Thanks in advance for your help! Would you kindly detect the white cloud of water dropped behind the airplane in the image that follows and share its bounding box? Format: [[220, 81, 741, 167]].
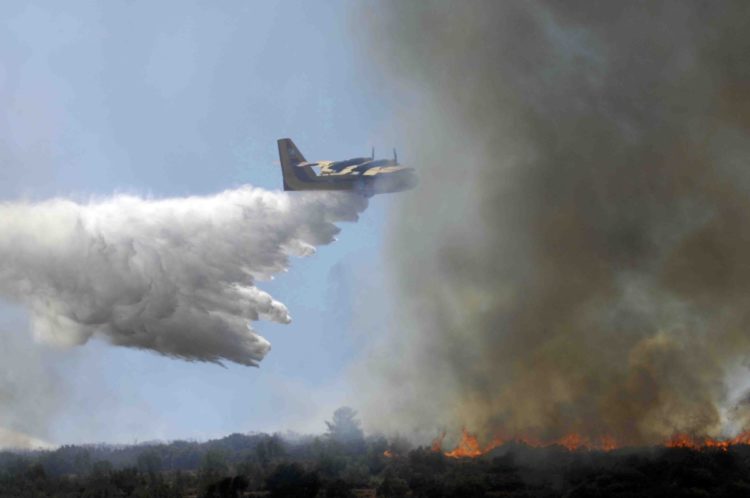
[[0, 187, 366, 365]]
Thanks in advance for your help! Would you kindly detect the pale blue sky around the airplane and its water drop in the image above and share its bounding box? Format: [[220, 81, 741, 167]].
[[0, 0, 400, 443]]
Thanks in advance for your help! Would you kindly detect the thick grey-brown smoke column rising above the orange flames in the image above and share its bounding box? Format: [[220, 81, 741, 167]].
[[362, 1, 750, 443]]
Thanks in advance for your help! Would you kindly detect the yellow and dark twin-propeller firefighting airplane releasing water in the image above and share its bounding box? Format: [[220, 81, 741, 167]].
[[278, 138, 417, 197]]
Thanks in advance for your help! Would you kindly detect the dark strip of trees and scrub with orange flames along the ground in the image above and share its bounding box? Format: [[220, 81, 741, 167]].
[[7, 431, 750, 498]]
